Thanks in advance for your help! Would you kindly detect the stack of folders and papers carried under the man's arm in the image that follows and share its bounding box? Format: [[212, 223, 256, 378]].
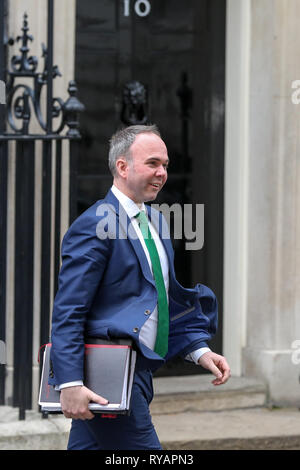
[[39, 338, 136, 414]]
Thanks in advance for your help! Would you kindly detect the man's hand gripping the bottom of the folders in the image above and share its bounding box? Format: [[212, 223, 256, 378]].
[[60, 385, 108, 419]]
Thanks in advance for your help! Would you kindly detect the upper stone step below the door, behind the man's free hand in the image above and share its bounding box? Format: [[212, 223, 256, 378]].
[[150, 375, 267, 415]]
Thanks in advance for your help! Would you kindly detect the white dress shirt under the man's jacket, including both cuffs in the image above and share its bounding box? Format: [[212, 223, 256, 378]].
[[58, 185, 210, 390]]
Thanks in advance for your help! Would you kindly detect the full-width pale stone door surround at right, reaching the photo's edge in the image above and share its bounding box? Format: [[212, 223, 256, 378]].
[[223, 0, 300, 406]]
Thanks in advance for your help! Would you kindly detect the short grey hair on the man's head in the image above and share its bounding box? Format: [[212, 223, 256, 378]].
[[108, 124, 161, 176]]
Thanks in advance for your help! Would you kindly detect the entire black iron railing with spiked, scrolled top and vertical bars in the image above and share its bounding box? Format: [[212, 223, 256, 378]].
[[0, 0, 84, 419]]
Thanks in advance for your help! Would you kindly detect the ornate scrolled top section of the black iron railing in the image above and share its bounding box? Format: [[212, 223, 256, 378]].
[[4, 11, 84, 138]]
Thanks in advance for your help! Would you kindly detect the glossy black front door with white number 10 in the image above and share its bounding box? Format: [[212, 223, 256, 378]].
[[75, 0, 226, 375]]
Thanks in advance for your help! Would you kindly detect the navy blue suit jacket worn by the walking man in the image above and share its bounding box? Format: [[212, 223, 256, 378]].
[[50, 191, 217, 384]]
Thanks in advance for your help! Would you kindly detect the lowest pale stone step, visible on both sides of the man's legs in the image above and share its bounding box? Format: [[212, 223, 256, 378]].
[[0, 407, 300, 450]]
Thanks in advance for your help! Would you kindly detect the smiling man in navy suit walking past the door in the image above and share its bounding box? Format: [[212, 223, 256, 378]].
[[50, 126, 230, 449]]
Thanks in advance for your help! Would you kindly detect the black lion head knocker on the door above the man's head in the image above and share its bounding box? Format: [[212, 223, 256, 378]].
[[121, 81, 148, 126]]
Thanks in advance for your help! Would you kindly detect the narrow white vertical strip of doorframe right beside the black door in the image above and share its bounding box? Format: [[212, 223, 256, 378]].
[[223, 0, 251, 376]]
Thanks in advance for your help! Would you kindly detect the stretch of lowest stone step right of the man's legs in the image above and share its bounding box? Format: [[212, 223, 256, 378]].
[[153, 408, 300, 450]]
